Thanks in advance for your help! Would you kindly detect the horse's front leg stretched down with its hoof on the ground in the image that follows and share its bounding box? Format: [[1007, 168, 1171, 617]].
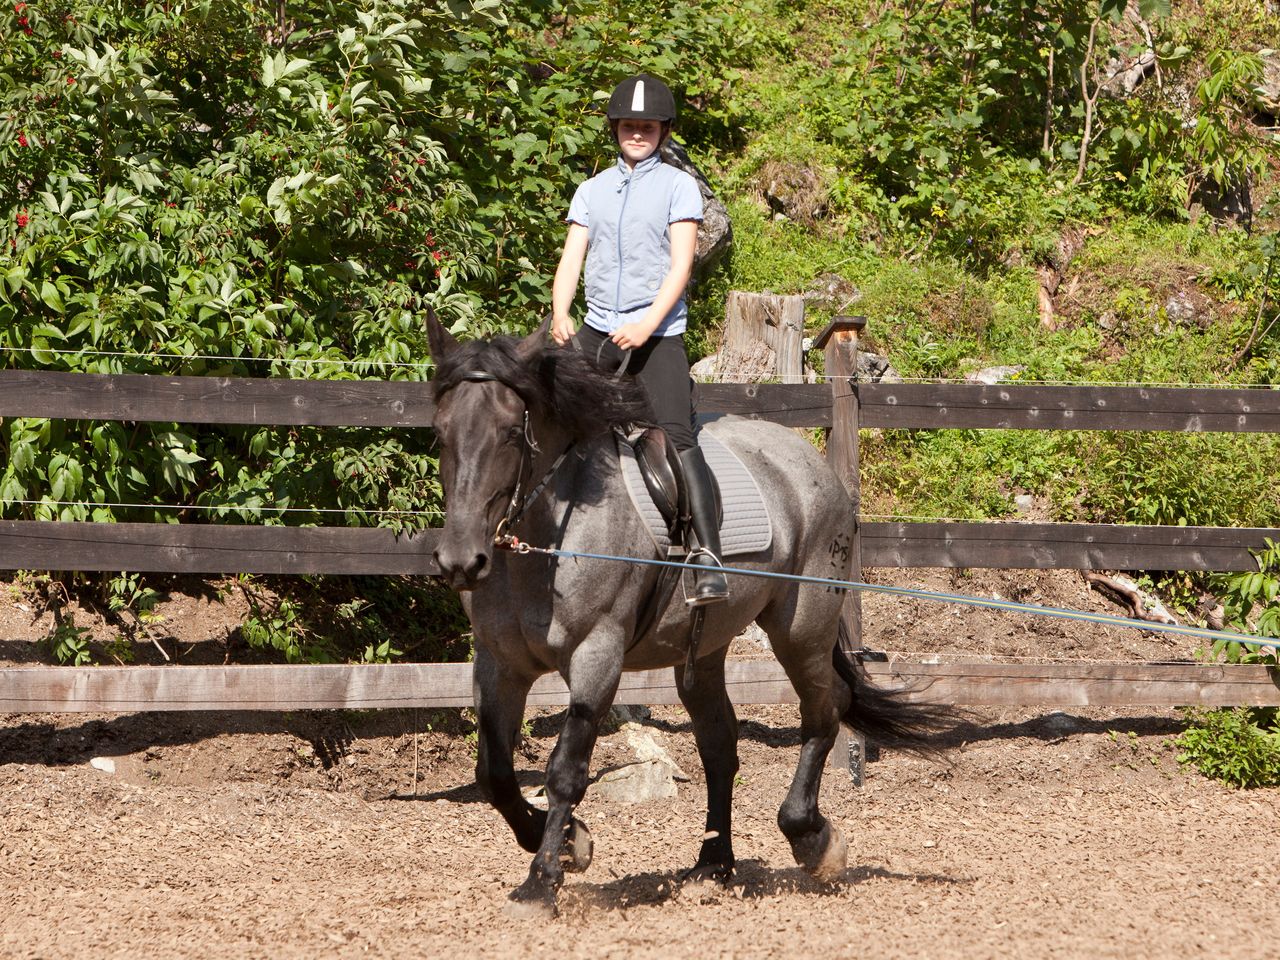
[[511, 640, 622, 918]]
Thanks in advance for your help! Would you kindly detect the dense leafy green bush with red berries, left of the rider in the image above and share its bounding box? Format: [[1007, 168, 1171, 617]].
[[0, 0, 755, 659]]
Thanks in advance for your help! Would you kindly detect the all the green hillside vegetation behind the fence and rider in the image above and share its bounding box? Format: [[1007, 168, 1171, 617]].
[[0, 0, 1280, 659]]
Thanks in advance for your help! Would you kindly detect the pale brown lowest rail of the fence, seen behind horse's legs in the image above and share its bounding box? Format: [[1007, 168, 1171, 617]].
[[0, 660, 1280, 713]]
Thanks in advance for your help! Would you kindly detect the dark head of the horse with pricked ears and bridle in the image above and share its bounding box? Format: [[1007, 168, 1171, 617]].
[[426, 312, 547, 590]]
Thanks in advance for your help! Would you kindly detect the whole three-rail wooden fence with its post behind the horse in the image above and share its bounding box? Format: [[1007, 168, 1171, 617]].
[[0, 317, 1280, 712]]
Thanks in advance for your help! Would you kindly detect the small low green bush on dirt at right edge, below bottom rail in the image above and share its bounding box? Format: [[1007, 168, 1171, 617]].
[[1176, 707, 1280, 787]]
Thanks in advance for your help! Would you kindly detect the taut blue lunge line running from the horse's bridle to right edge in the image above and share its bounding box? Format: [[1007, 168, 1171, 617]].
[[534, 548, 1280, 649]]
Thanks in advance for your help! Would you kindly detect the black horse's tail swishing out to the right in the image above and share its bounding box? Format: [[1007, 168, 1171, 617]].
[[831, 621, 964, 759]]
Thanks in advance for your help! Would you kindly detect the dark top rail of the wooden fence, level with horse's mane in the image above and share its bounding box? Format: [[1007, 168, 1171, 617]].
[[0, 370, 1280, 433]]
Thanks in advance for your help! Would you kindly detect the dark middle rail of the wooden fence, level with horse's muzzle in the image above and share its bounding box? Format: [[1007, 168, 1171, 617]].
[[0, 520, 1280, 576]]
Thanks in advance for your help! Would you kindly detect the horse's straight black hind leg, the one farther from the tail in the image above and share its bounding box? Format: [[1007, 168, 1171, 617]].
[[676, 646, 737, 882]]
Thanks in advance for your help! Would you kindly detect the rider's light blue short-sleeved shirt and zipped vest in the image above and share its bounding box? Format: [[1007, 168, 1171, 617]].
[[566, 154, 703, 337]]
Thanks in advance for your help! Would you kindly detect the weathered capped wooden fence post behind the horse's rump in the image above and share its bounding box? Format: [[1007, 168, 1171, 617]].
[[813, 316, 867, 786]]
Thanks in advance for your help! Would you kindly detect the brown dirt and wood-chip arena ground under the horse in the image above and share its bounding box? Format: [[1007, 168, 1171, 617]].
[[0, 572, 1280, 960]]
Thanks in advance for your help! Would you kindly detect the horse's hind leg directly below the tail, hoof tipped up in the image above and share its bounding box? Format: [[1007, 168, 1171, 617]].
[[760, 604, 849, 881]]
